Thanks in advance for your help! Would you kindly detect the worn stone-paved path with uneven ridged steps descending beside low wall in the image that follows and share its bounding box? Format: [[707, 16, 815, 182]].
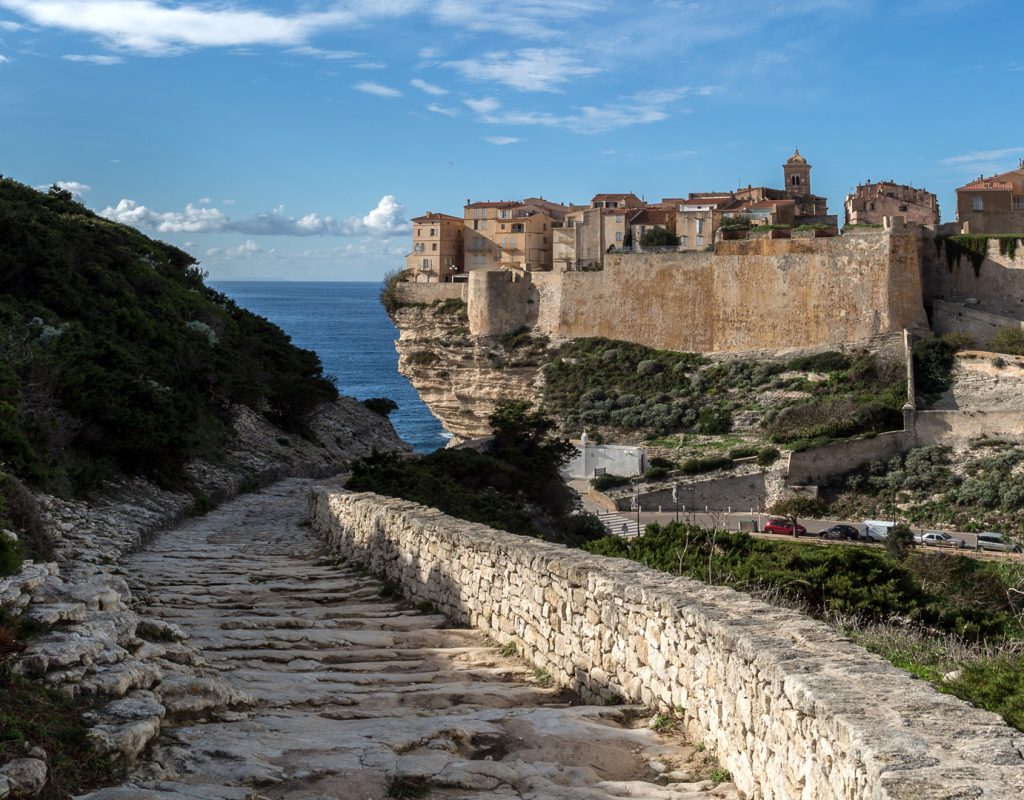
[[77, 480, 737, 800]]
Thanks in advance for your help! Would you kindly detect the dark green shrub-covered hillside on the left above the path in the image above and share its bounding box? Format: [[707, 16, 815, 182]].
[[0, 179, 337, 549]]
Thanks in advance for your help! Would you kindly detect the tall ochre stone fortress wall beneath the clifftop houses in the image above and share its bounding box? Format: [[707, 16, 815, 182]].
[[469, 227, 925, 352]]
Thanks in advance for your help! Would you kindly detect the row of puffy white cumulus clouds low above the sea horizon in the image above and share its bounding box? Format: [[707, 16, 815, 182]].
[[99, 195, 410, 238]]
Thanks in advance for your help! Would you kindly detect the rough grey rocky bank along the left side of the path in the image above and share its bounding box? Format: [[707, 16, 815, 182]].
[[0, 397, 408, 799]]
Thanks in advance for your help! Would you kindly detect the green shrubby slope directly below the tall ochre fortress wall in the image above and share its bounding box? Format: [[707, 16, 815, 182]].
[[544, 338, 906, 450]]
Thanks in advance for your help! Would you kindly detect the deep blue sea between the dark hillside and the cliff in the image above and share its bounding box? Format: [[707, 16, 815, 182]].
[[208, 281, 450, 453]]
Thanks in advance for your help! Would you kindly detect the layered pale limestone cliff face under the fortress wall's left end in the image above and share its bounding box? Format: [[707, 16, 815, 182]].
[[395, 305, 550, 440]]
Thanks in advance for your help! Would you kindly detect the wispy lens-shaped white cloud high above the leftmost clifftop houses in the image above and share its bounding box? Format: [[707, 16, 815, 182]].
[[444, 47, 602, 92]]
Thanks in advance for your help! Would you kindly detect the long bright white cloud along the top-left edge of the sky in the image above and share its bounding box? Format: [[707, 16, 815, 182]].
[[0, 0, 419, 54]]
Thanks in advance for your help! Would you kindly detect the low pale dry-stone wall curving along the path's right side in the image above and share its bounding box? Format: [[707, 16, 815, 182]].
[[310, 491, 1024, 800]]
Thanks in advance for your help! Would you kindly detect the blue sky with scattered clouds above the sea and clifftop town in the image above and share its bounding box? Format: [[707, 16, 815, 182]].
[[0, 0, 1024, 281]]
